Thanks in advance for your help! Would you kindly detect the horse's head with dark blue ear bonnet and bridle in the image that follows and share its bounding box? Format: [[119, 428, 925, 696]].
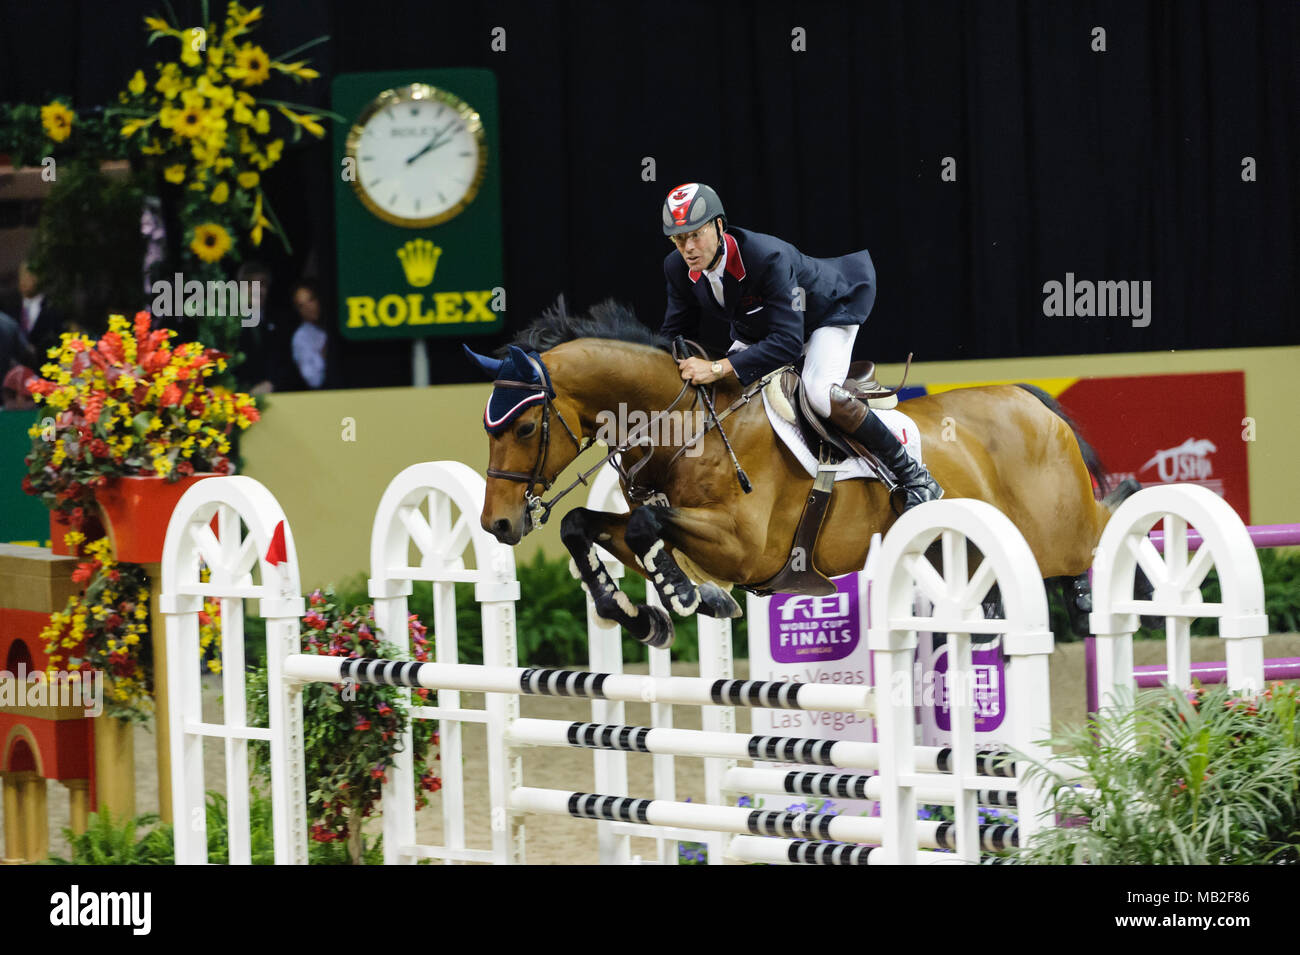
[[465, 346, 582, 544]]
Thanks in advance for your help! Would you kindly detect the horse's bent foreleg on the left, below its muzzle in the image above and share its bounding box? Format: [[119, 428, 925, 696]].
[[560, 507, 673, 648]]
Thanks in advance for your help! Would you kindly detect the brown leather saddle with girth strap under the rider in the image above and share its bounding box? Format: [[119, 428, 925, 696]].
[[748, 355, 911, 596]]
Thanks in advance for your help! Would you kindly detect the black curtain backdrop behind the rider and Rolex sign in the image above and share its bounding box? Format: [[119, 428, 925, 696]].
[[0, 0, 1300, 385]]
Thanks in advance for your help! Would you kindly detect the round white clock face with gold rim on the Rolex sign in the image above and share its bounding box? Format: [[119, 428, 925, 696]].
[[347, 83, 488, 229]]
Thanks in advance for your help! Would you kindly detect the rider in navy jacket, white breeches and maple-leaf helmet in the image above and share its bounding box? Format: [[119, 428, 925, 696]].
[[660, 182, 944, 511]]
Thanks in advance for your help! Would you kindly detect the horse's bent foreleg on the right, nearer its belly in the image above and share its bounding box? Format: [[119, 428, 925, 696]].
[[623, 507, 744, 617]]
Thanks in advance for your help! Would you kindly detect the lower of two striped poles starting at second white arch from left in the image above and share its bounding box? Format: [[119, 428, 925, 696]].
[[510, 786, 1017, 851]]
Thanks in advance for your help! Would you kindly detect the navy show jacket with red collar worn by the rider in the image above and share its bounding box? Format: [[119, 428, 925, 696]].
[[660, 227, 876, 385]]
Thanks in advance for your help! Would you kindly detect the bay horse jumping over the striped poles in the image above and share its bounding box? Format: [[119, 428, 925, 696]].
[[465, 303, 1110, 646]]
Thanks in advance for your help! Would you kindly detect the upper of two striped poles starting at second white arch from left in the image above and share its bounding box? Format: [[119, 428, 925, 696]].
[[510, 720, 1014, 776]]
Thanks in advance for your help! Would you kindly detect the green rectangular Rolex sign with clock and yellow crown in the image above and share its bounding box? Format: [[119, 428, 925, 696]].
[[332, 69, 506, 339]]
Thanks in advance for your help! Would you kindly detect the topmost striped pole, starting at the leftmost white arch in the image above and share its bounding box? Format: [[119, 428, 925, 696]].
[[285, 654, 874, 713]]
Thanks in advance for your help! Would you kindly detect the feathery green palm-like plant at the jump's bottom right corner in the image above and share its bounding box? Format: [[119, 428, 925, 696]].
[[1015, 683, 1300, 865]]
